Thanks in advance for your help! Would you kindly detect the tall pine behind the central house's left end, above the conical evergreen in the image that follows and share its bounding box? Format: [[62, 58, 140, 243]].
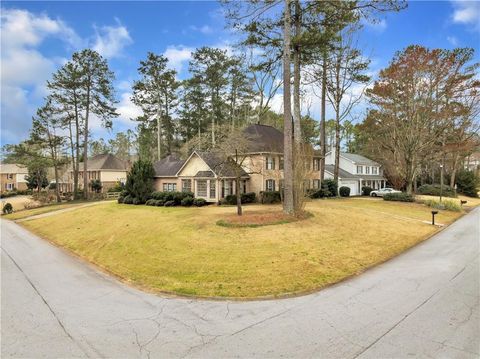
[[132, 52, 180, 159]]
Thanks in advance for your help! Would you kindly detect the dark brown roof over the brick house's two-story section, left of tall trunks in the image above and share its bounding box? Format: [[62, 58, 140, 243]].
[[243, 124, 283, 153]]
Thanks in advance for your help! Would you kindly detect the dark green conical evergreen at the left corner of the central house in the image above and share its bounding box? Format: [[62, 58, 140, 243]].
[[125, 160, 155, 203]]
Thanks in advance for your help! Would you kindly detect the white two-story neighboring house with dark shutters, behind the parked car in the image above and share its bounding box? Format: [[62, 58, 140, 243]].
[[325, 151, 387, 196]]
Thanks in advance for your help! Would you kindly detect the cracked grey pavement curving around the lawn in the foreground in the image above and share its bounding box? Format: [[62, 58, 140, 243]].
[[1, 209, 480, 358]]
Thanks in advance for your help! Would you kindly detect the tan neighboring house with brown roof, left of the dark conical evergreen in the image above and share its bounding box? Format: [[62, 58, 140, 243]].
[[65, 154, 128, 192]]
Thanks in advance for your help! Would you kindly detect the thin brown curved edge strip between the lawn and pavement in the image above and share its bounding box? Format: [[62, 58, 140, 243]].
[[4, 210, 470, 302]]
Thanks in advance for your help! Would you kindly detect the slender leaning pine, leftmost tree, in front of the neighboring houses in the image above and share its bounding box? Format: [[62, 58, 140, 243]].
[[30, 98, 65, 202]]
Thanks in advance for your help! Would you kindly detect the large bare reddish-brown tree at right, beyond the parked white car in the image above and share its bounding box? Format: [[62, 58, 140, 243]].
[[362, 46, 478, 193]]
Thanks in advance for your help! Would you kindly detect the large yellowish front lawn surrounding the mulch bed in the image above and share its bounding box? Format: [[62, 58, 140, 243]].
[[17, 198, 461, 298]]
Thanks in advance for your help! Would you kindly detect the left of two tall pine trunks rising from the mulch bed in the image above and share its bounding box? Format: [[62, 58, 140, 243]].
[[283, 0, 295, 214]]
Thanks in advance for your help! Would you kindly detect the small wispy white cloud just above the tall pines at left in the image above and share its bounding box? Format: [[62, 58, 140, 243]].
[[93, 20, 133, 58]]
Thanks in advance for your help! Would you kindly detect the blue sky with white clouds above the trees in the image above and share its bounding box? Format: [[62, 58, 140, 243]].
[[0, 0, 480, 146]]
